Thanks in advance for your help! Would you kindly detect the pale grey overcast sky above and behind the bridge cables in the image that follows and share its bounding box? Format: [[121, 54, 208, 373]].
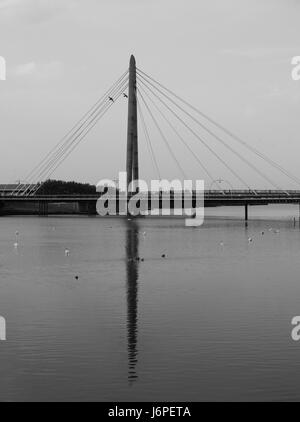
[[0, 0, 300, 188]]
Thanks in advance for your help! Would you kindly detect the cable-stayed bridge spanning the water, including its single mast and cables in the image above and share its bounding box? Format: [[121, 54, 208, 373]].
[[0, 56, 300, 219]]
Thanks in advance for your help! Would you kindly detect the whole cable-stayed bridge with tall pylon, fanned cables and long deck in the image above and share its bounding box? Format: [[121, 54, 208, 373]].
[[0, 56, 300, 220]]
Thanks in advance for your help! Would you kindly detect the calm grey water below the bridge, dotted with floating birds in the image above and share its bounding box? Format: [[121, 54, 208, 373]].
[[0, 207, 300, 401]]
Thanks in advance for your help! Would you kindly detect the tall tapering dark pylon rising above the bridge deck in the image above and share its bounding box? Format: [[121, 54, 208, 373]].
[[126, 56, 139, 192]]
